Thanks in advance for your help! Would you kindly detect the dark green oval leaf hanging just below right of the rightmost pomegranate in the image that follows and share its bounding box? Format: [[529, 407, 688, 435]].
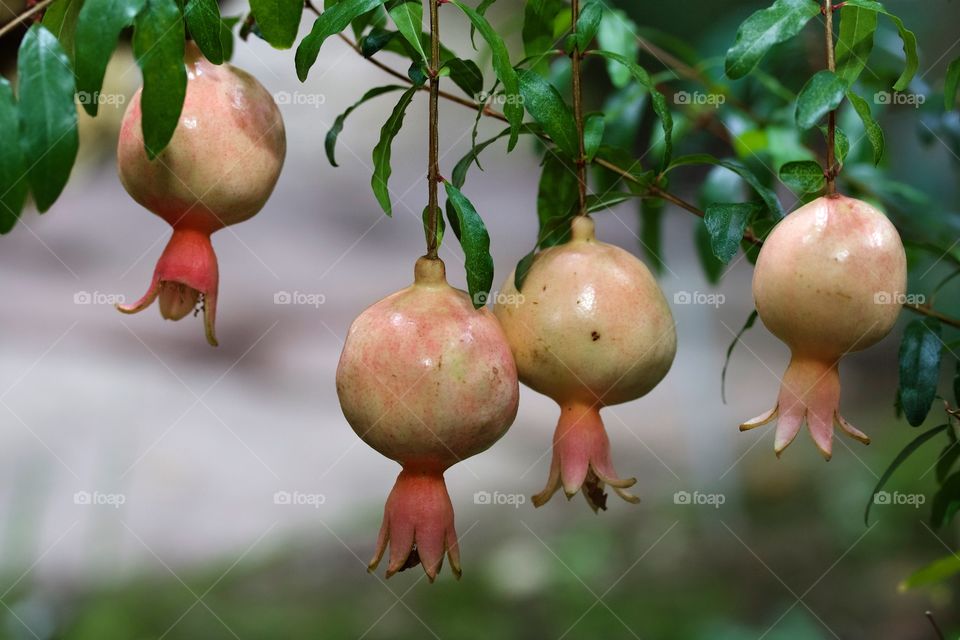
[[899, 318, 943, 427]]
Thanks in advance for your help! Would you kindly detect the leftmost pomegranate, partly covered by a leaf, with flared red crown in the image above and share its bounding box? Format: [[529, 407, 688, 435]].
[[117, 42, 287, 346]]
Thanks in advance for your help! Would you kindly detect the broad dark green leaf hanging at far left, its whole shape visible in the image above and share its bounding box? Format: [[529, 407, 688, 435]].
[[17, 24, 79, 212]]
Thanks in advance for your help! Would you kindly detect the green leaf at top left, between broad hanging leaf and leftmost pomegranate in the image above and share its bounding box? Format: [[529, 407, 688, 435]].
[[75, 0, 146, 116]]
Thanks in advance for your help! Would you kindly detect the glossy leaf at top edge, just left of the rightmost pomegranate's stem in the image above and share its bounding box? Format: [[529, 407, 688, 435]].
[[725, 0, 820, 80]]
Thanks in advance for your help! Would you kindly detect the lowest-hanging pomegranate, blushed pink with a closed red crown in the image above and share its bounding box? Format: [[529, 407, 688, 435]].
[[337, 257, 520, 582]]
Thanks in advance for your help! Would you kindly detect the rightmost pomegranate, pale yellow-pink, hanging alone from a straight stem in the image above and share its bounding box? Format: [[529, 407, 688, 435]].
[[740, 195, 907, 460]]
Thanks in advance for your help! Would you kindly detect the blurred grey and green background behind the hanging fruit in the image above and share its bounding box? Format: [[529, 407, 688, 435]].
[[0, 0, 960, 640]]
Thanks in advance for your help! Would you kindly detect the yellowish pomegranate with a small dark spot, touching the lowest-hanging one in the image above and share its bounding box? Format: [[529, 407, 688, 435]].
[[495, 217, 677, 511]]
